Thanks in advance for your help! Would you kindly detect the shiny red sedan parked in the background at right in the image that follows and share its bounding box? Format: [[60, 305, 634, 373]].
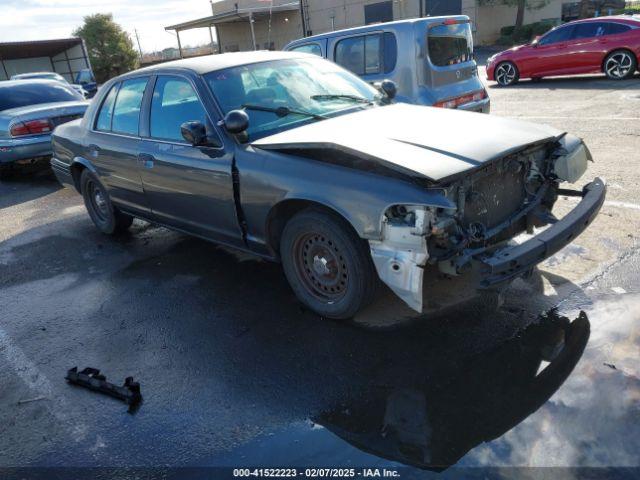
[[487, 16, 640, 86]]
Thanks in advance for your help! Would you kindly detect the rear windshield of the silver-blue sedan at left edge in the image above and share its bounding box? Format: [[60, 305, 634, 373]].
[[0, 82, 84, 111]]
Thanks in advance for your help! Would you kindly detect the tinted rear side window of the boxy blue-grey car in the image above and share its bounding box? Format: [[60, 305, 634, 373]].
[[336, 34, 382, 75]]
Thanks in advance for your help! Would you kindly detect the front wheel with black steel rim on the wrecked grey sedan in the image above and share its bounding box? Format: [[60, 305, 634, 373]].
[[280, 209, 378, 320]]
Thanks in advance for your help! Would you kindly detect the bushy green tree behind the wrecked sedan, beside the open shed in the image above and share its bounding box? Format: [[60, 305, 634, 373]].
[[73, 13, 138, 83]]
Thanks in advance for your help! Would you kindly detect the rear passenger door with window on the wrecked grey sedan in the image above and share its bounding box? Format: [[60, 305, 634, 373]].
[[85, 77, 149, 212]]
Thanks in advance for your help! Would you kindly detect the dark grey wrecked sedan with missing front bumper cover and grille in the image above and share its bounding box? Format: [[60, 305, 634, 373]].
[[51, 52, 606, 319]]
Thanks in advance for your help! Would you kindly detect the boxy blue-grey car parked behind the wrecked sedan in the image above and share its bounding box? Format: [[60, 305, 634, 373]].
[[284, 15, 490, 113]]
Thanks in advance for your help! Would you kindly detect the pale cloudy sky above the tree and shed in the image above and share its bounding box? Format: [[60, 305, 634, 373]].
[[0, 0, 218, 53]]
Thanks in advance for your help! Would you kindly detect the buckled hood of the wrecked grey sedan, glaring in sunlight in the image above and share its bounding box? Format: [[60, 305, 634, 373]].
[[252, 104, 562, 181]]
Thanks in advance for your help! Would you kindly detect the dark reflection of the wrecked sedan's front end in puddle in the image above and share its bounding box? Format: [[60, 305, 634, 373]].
[[314, 313, 590, 470]]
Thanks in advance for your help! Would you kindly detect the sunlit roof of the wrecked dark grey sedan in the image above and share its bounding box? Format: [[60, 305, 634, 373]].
[[133, 50, 318, 77]]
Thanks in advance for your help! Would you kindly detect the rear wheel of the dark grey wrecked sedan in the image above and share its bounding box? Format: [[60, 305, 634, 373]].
[[80, 169, 133, 235]]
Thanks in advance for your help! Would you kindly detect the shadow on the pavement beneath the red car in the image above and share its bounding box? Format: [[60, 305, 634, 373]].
[[488, 73, 640, 90]]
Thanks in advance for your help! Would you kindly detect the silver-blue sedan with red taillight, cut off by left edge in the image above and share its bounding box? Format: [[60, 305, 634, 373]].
[[0, 80, 87, 178]]
